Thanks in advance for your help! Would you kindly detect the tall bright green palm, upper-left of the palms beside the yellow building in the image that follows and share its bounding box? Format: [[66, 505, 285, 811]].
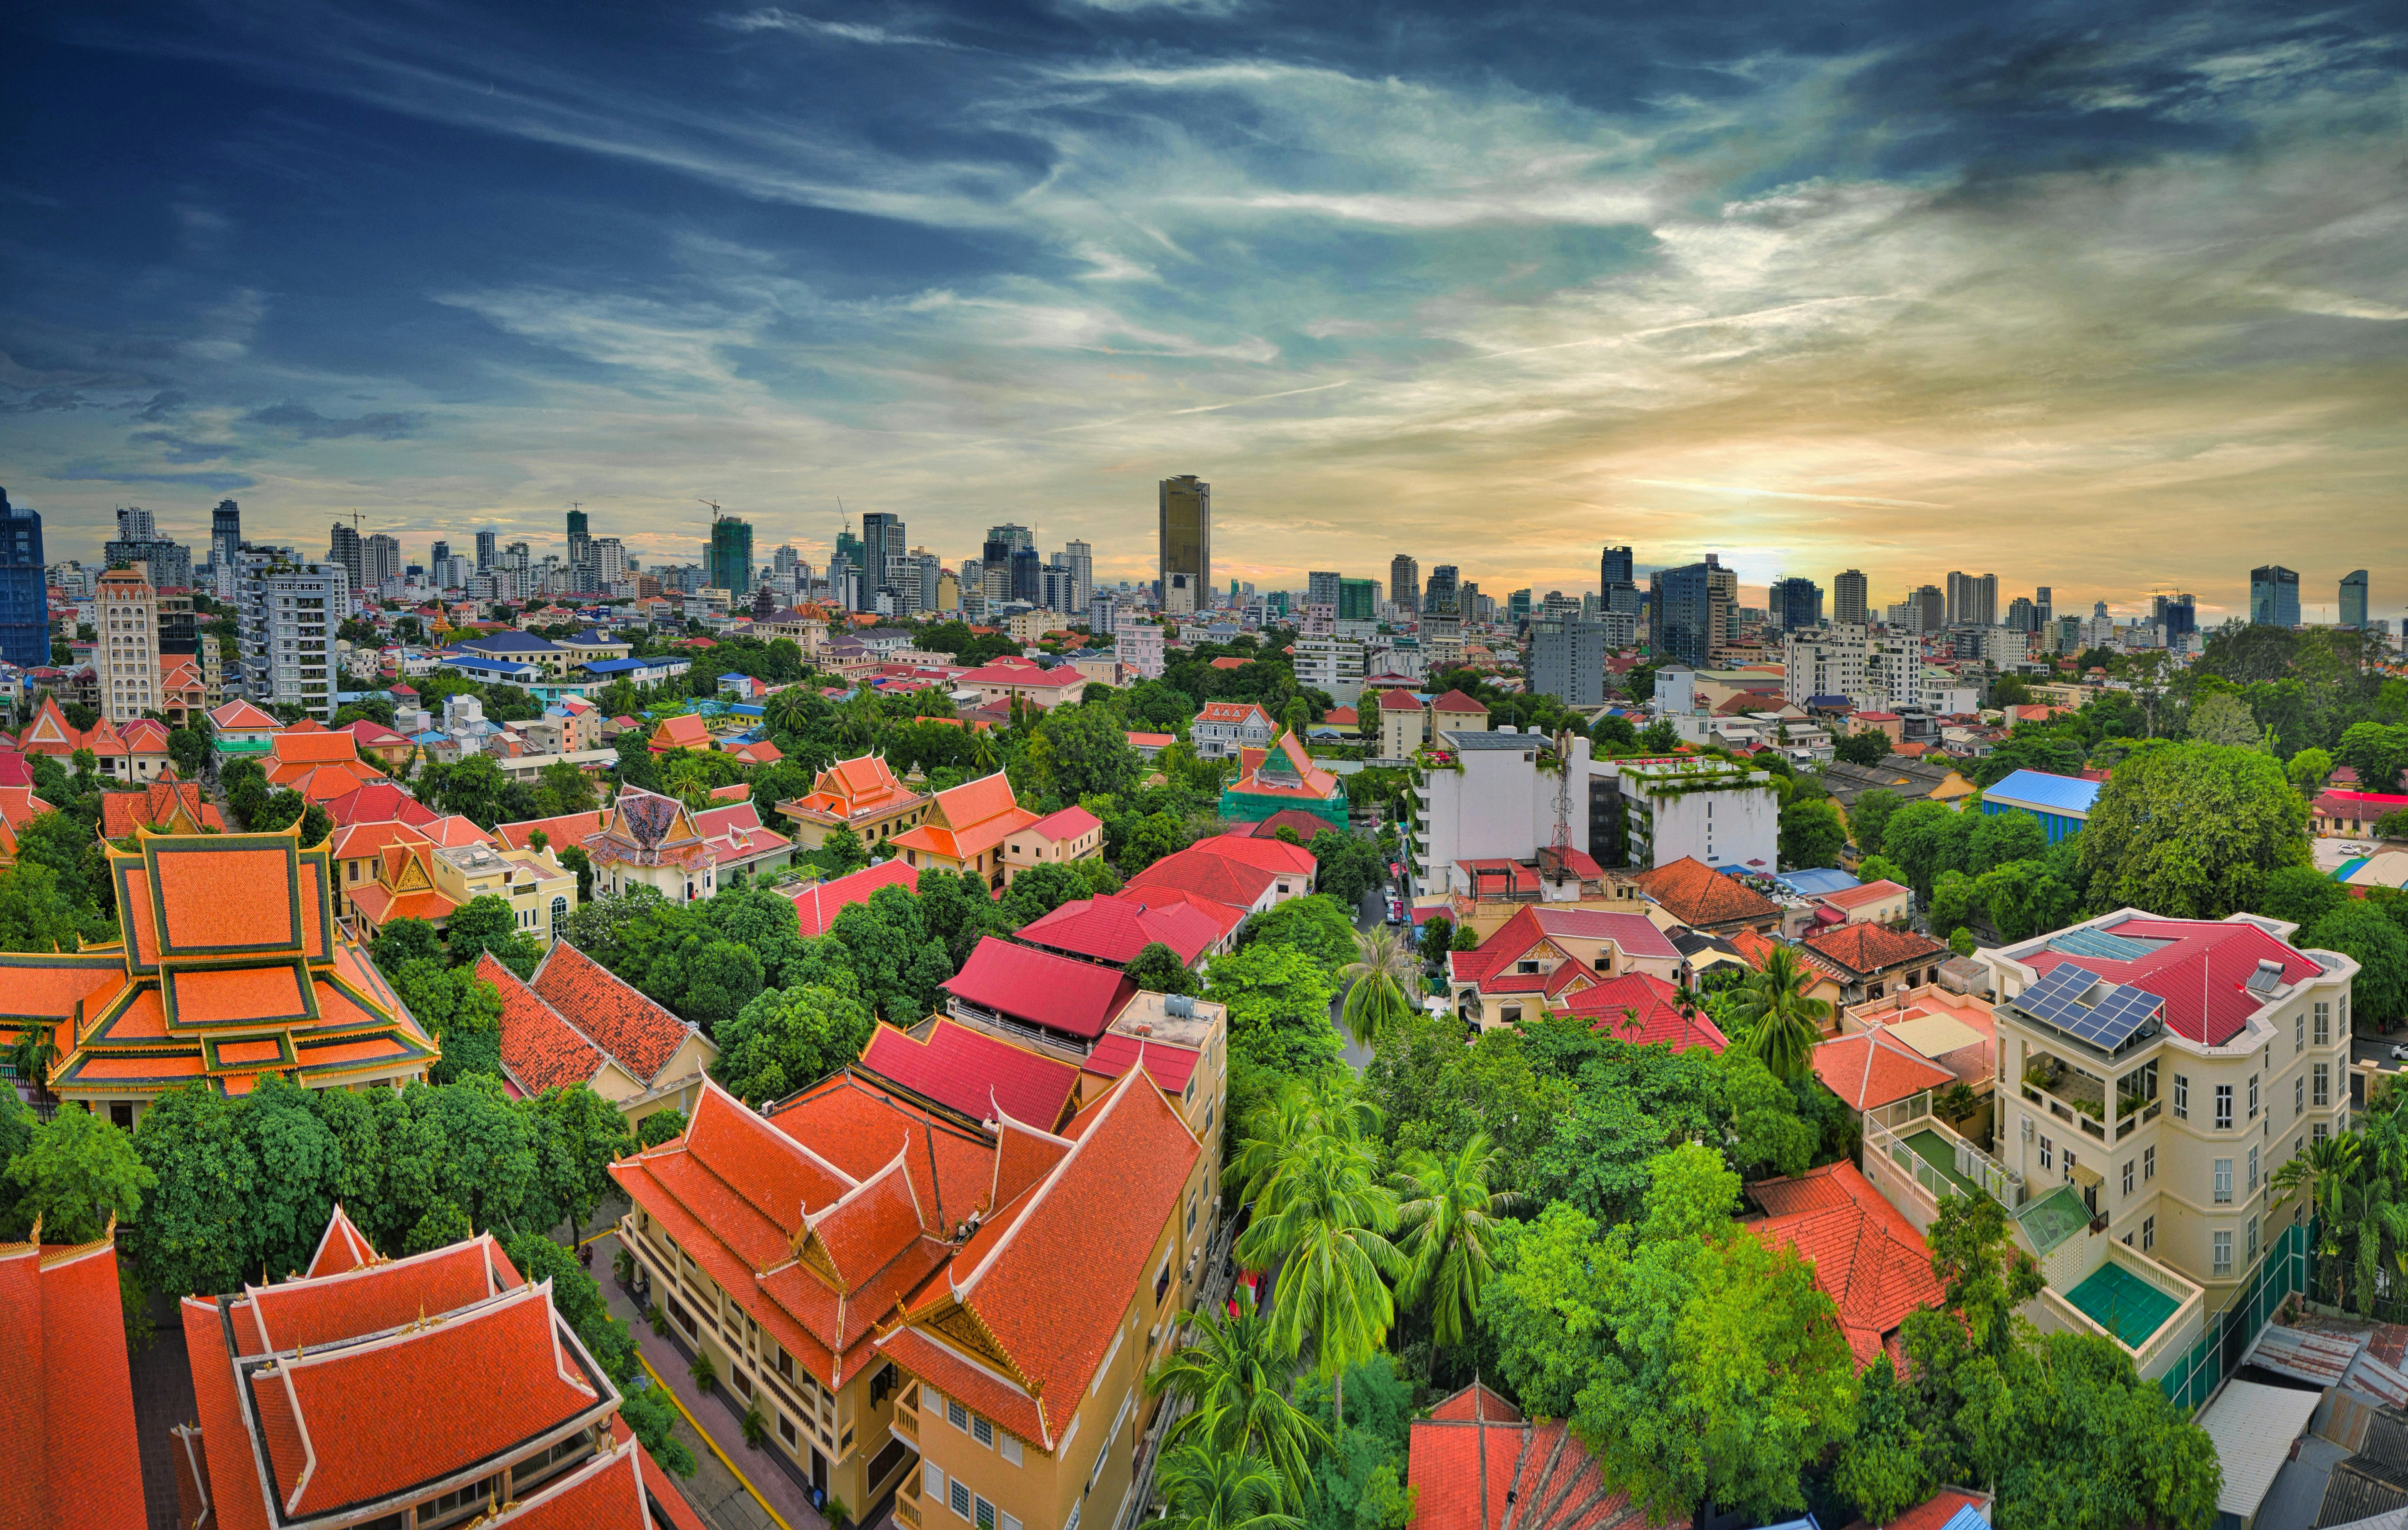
[[1238, 1128, 1406, 1434]]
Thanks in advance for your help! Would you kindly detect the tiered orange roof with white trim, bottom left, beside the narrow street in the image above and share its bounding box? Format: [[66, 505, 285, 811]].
[[166, 1207, 701, 1530]]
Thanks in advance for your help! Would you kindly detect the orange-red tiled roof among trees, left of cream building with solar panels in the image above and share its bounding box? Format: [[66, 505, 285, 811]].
[[1751, 1161, 1941, 1371]]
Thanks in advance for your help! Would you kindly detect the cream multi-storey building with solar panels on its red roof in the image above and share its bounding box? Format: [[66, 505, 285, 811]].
[[1982, 908, 2358, 1313]]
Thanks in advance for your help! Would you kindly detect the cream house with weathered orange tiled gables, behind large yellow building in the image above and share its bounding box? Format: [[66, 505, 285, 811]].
[[477, 940, 720, 1125]]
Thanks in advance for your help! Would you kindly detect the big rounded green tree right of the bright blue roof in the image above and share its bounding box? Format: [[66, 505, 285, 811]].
[[2081, 745, 2307, 918]]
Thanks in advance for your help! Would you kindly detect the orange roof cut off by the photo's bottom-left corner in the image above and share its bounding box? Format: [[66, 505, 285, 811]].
[[0, 1229, 149, 1530]]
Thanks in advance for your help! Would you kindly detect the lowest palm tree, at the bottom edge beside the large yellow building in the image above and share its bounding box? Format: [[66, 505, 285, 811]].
[[1146, 1296, 1329, 1503]]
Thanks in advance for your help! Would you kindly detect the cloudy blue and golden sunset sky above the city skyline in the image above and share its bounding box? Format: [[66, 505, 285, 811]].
[[0, 0, 2408, 622]]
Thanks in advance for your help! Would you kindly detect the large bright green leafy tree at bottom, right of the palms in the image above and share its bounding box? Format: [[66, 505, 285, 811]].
[[1486, 1145, 1857, 1520]]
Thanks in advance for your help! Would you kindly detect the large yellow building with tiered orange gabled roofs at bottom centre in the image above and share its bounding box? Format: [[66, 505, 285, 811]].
[[612, 1041, 1223, 1525]]
